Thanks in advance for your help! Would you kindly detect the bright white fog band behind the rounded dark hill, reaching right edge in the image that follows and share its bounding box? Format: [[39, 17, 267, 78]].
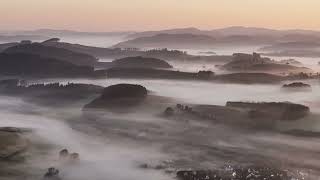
[[34, 79, 320, 112]]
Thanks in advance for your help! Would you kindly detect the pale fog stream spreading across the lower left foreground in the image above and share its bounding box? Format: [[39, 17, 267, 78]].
[[0, 97, 170, 180]]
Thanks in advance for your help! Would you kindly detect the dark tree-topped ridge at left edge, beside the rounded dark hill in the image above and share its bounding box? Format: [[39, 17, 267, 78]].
[[0, 79, 103, 107]]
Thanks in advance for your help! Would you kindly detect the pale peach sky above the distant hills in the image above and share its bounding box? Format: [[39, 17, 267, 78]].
[[0, 0, 320, 31]]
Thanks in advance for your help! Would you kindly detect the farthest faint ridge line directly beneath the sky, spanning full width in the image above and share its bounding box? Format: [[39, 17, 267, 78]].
[[0, 26, 320, 39]]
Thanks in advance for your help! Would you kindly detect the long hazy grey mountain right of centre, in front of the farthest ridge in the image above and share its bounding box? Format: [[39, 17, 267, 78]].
[[113, 34, 277, 49]]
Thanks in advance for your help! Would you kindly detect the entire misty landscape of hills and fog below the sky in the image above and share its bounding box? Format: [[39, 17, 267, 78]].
[[0, 27, 320, 180]]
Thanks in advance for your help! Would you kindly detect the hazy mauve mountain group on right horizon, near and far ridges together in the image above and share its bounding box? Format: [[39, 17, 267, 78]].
[[114, 26, 320, 49]]
